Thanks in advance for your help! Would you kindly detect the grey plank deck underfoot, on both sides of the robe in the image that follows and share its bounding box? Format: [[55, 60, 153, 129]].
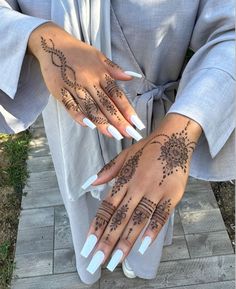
[[11, 119, 235, 289]]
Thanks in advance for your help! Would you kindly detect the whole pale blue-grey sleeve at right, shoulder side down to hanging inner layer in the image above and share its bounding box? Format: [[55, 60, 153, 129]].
[[168, 0, 235, 179]]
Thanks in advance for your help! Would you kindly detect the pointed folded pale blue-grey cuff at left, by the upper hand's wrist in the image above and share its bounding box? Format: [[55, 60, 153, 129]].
[[0, 7, 49, 99]]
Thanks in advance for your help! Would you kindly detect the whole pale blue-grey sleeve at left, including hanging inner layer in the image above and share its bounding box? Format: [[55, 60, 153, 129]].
[[0, 0, 48, 133]]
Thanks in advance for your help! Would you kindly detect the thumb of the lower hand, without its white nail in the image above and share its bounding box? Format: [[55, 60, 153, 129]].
[[93, 151, 127, 186]]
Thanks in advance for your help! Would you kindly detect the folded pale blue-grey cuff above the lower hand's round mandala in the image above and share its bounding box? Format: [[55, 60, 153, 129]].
[[167, 68, 235, 158]]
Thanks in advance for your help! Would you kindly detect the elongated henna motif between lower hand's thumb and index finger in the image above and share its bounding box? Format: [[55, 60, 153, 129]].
[[111, 148, 143, 197]]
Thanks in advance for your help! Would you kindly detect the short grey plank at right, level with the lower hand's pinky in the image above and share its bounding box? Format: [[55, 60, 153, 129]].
[[180, 209, 225, 234]]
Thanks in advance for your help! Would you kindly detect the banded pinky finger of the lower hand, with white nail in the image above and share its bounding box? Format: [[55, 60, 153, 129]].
[[138, 198, 174, 255]]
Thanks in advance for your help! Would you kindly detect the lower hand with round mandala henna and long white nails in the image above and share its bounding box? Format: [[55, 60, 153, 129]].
[[81, 114, 202, 274]]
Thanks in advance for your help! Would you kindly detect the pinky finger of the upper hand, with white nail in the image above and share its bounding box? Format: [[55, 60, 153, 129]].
[[61, 88, 96, 129]]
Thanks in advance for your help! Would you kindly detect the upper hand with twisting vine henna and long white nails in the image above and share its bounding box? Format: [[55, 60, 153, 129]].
[[28, 23, 144, 140]]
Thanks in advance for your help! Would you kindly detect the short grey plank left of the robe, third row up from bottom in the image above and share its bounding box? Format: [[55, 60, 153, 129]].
[[15, 226, 54, 255]]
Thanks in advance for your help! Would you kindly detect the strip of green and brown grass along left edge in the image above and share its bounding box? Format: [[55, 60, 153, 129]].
[[0, 131, 31, 289]]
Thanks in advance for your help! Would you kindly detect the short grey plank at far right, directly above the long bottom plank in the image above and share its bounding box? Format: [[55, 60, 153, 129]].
[[185, 231, 233, 258]]
